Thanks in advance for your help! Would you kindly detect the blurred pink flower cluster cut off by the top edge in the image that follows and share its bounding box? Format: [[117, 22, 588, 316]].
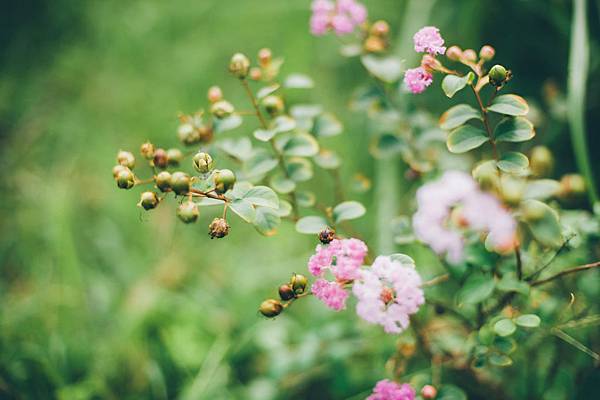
[[310, 0, 367, 36]]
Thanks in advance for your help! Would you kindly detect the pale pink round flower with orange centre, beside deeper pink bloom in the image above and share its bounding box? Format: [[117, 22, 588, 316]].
[[352, 256, 425, 333]]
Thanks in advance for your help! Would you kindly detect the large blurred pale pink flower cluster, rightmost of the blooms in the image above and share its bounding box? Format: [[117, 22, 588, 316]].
[[413, 171, 517, 263]]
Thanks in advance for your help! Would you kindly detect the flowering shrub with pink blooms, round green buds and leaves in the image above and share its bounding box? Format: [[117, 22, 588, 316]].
[[113, 0, 600, 400]]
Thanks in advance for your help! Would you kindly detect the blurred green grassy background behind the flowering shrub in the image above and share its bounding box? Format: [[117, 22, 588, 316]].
[[0, 0, 600, 399]]
